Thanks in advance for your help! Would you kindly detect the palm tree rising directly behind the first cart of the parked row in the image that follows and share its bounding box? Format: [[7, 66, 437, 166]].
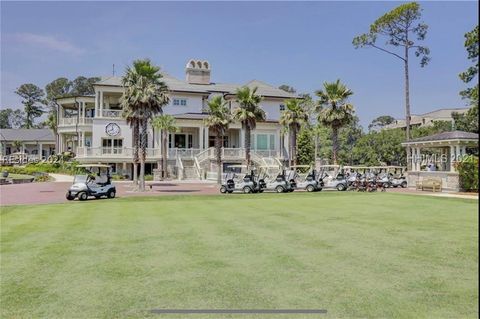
[[233, 86, 266, 166]]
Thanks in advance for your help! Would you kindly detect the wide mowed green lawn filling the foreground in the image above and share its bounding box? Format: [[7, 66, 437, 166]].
[[0, 192, 478, 318]]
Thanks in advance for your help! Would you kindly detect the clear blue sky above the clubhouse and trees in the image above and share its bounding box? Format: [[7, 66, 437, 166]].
[[1, 2, 478, 126]]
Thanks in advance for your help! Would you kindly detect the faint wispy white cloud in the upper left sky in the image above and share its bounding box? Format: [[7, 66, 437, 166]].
[[7, 33, 85, 55]]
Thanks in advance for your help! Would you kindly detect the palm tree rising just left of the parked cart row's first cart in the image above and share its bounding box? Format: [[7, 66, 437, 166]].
[[205, 95, 232, 184]]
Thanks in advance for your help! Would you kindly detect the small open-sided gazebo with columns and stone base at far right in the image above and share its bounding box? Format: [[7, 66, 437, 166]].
[[402, 131, 478, 192]]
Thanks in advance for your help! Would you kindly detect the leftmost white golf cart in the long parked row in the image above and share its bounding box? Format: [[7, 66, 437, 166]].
[[220, 165, 263, 194]]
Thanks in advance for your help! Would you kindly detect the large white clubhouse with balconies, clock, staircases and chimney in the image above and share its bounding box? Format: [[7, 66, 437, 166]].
[[57, 60, 297, 178]]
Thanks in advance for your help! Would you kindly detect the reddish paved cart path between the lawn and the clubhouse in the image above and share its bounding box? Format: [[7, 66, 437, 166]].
[[0, 181, 478, 206]]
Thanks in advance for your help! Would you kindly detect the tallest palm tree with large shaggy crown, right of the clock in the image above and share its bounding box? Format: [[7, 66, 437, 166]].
[[120, 59, 169, 191]]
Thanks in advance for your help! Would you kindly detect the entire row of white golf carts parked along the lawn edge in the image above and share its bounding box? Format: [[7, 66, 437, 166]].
[[220, 165, 407, 194]]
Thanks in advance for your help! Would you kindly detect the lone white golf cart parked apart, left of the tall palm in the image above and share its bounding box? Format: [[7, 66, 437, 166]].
[[66, 164, 117, 201]]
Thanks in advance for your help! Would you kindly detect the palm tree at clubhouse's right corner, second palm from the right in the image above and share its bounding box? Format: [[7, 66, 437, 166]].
[[280, 99, 308, 165]]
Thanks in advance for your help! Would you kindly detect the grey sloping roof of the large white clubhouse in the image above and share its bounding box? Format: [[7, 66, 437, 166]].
[[95, 73, 298, 99]]
